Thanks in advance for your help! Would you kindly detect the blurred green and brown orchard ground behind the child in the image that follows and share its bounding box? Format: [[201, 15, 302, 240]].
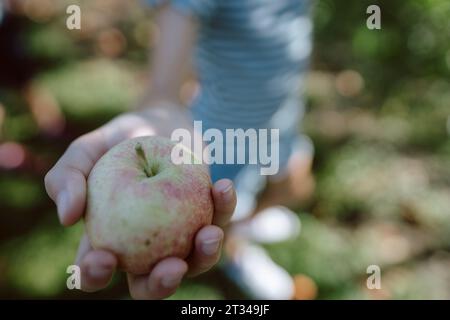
[[0, 0, 450, 299]]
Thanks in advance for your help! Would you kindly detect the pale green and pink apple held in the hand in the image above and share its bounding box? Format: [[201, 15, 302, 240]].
[[84, 137, 213, 274]]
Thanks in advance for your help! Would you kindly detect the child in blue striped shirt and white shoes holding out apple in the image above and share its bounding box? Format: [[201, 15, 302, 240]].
[[45, 0, 314, 299]]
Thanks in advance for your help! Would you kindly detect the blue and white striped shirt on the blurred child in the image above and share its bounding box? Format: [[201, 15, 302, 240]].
[[147, 0, 312, 130]]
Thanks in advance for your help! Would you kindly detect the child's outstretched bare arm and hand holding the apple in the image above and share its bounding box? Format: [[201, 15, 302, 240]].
[[45, 6, 236, 299]]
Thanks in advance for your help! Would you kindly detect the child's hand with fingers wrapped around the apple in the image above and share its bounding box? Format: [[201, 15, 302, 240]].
[[45, 106, 236, 299]]
